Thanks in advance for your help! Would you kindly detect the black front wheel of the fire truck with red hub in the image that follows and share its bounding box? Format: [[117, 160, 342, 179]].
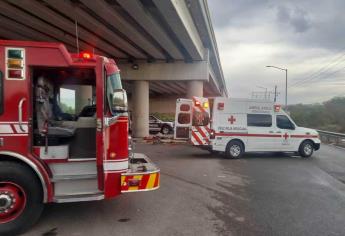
[[0, 161, 43, 235]]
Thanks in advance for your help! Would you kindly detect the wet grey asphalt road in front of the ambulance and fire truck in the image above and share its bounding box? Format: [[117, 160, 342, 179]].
[[26, 144, 345, 236]]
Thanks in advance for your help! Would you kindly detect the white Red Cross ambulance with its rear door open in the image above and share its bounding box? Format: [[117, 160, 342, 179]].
[[174, 97, 320, 158]]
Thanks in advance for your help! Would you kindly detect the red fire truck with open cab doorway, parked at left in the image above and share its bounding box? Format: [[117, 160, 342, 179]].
[[0, 40, 159, 235]]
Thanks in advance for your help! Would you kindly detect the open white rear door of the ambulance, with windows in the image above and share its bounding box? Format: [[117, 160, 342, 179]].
[[174, 99, 193, 139]]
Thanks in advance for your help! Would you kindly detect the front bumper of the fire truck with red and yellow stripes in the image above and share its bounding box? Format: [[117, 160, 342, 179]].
[[121, 153, 160, 193]]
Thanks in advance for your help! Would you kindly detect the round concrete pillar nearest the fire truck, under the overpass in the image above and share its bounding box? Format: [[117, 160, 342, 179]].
[[132, 80, 149, 138]]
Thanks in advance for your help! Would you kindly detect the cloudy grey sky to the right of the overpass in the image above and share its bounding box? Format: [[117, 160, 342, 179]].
[[208, 0, 345, 104]]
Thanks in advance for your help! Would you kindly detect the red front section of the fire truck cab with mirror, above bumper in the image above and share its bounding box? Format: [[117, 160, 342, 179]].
[[103, 63, 129, 198]]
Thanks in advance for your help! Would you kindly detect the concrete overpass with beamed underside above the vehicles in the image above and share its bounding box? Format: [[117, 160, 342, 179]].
[[0, 0, 227, 137]]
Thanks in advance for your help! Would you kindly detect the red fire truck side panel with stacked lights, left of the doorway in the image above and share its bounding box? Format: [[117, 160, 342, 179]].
[[0, 47, 31, 155]]
